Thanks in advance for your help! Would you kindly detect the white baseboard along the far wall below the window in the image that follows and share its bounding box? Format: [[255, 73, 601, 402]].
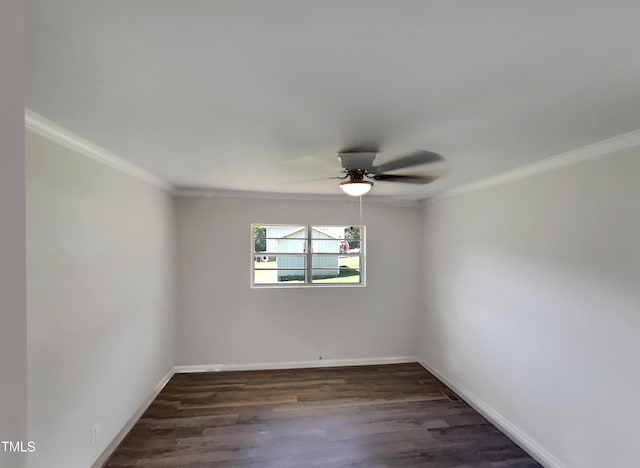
[[173, 356, 419, 373]]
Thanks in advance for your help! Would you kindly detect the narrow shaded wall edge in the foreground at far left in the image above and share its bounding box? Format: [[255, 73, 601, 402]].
[[0, 0, 27, 468]]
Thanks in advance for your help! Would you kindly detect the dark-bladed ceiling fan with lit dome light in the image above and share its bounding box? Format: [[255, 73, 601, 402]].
[[335, 148, 443, 197]]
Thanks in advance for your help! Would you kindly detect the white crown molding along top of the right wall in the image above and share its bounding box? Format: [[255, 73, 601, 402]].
[[423, 129, 640, 203]]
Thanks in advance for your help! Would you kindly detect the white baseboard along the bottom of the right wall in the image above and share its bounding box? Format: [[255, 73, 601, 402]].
[[418, 359, 568, 468]]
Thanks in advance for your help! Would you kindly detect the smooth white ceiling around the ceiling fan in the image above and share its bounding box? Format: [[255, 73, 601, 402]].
[[25, 0, 640, 199]]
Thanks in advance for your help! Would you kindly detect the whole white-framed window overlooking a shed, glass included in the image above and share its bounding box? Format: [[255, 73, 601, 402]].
[[251, 224, 365, 287]]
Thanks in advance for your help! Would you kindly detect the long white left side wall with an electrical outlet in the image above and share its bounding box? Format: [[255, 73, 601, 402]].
[[26, 133, 174, 468]]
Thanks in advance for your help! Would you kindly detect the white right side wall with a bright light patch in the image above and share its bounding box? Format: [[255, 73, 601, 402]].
[[422, 148, 640, 468]]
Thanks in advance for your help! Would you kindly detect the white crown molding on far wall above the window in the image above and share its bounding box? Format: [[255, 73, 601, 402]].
[[173, 187, 420, 207]]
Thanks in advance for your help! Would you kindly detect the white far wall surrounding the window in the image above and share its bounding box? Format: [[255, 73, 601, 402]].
[[176, 197, 421, 365]]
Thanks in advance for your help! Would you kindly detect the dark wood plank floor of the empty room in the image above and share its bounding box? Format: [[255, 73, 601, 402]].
[[105, 364, 540, 468]]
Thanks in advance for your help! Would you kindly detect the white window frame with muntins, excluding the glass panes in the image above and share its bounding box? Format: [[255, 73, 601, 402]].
[[250, 223, 367, 289]]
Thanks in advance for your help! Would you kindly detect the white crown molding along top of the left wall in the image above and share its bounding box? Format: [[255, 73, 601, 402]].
[[24, 108, 173, 191]]
